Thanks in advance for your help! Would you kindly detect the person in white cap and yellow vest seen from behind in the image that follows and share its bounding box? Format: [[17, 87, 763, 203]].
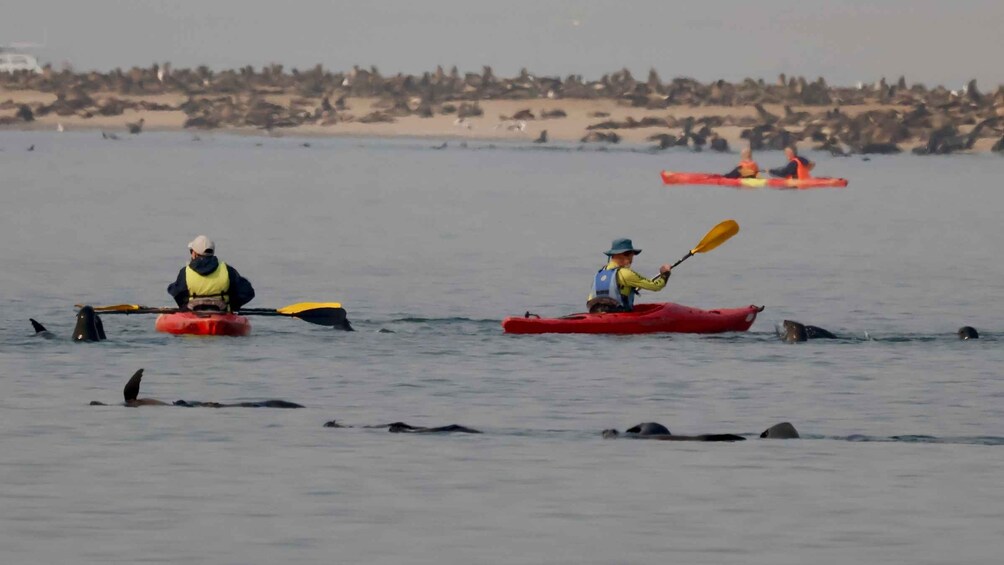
[[168, 236, 254, 312]]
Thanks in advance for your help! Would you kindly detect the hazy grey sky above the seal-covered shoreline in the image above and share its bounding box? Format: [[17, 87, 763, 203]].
[[0, 0, 1004, 90]]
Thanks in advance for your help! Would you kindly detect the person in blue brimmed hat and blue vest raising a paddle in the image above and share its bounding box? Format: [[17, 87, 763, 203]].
[[585, 238, 672, 313]]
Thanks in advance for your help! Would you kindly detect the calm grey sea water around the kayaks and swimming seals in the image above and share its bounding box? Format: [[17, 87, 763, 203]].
[[0, 132, 1004, 565]]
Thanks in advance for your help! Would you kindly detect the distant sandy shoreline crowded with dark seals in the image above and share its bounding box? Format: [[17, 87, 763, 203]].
[[0, 66, 1004, 155]]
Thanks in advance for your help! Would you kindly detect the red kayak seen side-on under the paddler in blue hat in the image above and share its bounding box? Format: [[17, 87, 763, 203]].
[[502, 302, 763, 334]]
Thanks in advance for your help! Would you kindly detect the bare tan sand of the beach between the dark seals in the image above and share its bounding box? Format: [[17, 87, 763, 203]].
[[0, 73, 1001, 153]]
